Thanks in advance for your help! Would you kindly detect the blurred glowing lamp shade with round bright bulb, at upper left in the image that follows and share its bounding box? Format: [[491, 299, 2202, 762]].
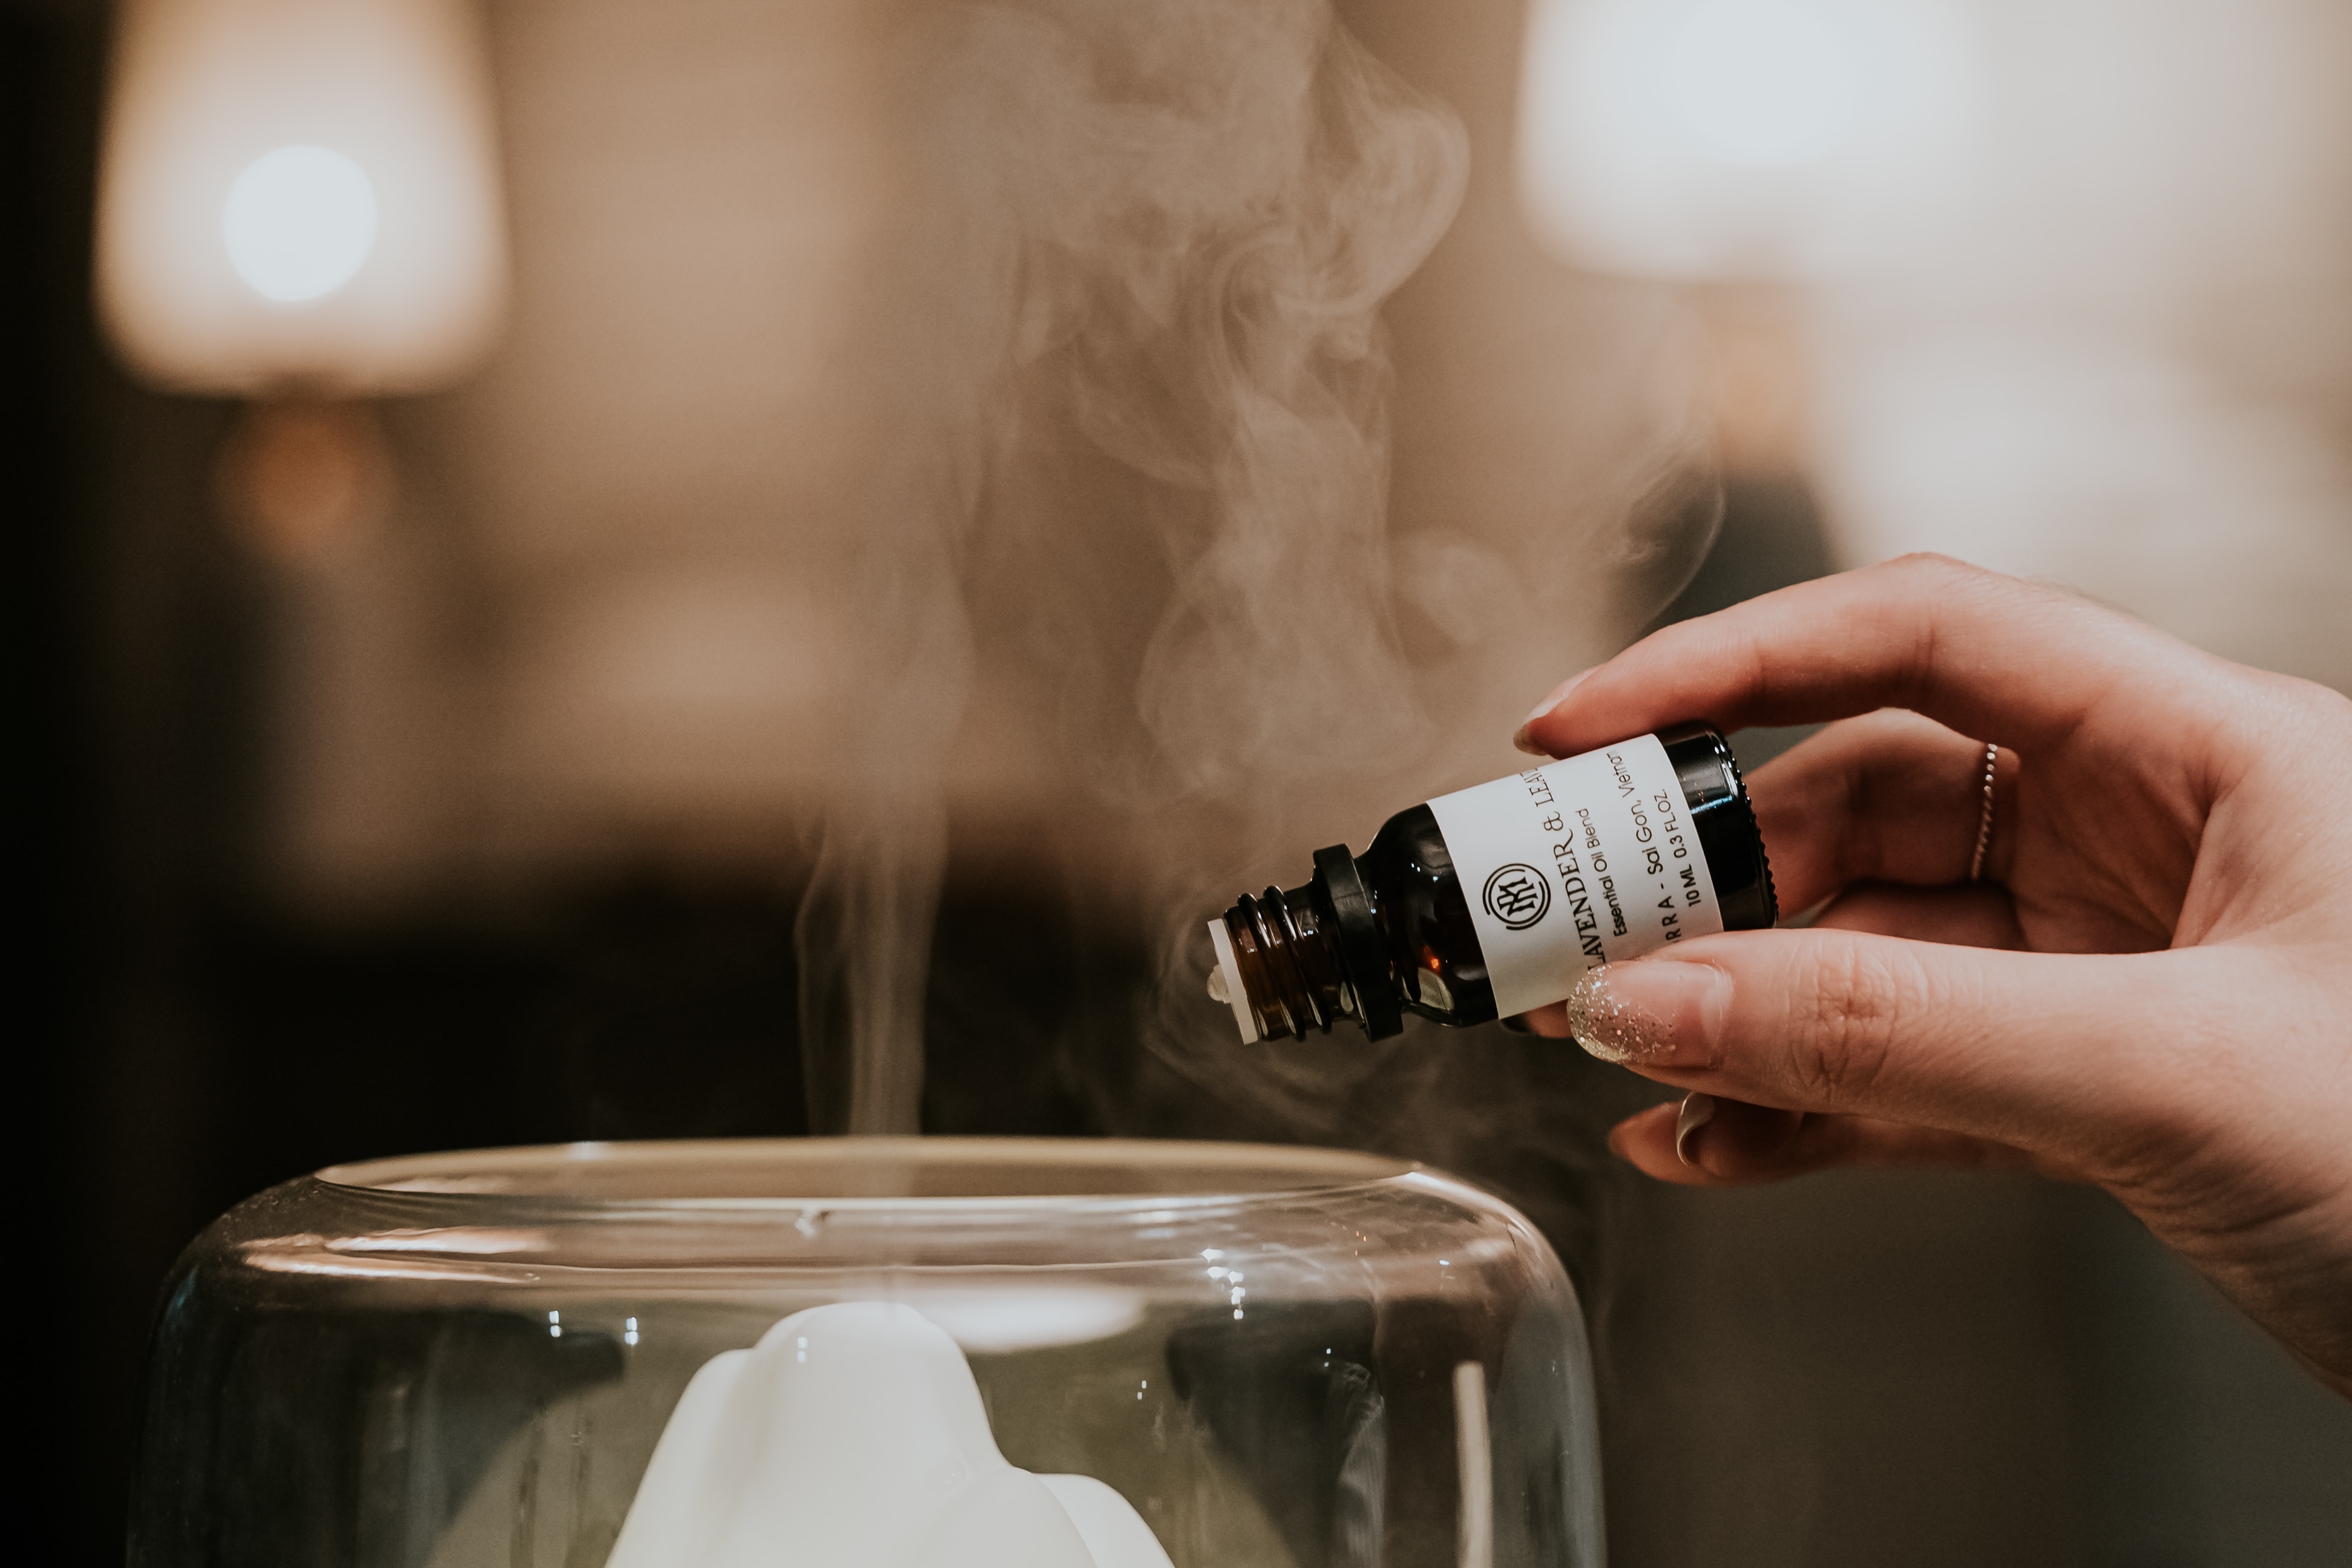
[[96, 0, 505, 395]]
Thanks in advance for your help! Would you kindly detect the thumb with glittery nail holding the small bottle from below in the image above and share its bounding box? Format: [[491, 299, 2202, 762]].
[[1566, 928, 2213, 1166]]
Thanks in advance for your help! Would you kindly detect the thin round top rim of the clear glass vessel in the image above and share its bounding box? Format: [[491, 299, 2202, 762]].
[[310, 1135, 1456, 1213]]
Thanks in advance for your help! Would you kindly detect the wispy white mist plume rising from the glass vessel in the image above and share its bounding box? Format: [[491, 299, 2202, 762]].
[[797, 0, 1468, 1130]]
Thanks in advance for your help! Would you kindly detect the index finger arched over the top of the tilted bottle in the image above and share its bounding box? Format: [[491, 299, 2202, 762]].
[[1522, 555, 2218, 757]]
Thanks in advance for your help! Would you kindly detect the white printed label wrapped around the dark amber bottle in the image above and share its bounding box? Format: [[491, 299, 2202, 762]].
[[1430, 736, 1724, 1018]]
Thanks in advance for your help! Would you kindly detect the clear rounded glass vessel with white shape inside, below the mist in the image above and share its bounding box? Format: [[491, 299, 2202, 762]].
[[130, 1138, 1601, 1568]]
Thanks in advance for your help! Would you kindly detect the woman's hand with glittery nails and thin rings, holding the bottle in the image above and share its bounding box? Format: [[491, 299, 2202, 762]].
[[1519, 557, 2352, 1394]]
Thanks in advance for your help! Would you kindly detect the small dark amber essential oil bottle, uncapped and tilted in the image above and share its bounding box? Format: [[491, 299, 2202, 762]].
[[1209, 724, 1781, 1039]]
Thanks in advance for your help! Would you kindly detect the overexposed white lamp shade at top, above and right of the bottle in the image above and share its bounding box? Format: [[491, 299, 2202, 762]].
[[1519, 0, 1978, 280]]
